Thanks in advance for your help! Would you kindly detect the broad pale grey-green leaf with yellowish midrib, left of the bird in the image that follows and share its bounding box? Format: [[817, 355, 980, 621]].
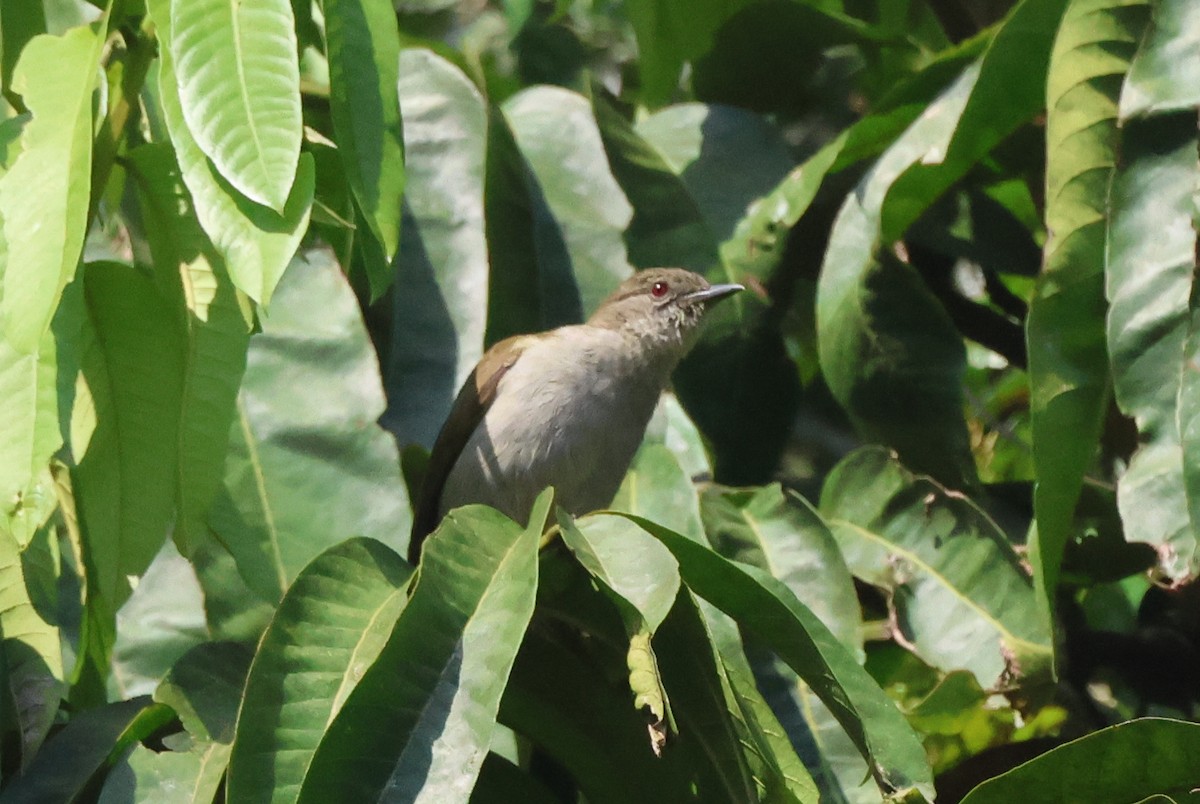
[[209, 250, 409, 604]]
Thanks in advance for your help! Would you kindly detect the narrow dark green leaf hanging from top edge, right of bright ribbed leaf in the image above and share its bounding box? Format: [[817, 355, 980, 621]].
[[324, 0, 408, 262]]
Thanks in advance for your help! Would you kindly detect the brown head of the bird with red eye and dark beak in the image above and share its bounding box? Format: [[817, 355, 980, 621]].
[[588, 268, 744, 356]]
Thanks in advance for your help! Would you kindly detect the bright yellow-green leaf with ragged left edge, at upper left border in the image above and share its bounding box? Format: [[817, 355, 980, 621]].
[[0, 24, 104, 354]]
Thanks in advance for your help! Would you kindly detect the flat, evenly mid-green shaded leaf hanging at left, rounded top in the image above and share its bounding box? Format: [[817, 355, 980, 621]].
[[72, 263, 186, 608]]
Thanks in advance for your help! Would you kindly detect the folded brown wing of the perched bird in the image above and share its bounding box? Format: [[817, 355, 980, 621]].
[[408, 335, 534, 565]]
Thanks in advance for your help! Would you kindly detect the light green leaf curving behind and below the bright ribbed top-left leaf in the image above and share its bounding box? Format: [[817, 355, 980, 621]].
[[148, 0, 316, 305]]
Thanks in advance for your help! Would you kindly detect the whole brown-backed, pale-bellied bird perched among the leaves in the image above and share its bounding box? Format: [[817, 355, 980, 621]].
[[408, 268, 745, 565]]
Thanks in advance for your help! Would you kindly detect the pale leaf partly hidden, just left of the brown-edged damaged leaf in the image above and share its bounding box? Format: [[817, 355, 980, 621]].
[[701, 484, 863, 656]]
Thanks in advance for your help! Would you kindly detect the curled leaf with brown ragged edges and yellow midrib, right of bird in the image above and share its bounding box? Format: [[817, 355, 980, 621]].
[[821, 448, 1051, 689]]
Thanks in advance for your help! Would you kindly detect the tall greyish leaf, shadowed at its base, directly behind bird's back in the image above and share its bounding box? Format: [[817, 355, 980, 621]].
[[383, 49, 488, 448]]
